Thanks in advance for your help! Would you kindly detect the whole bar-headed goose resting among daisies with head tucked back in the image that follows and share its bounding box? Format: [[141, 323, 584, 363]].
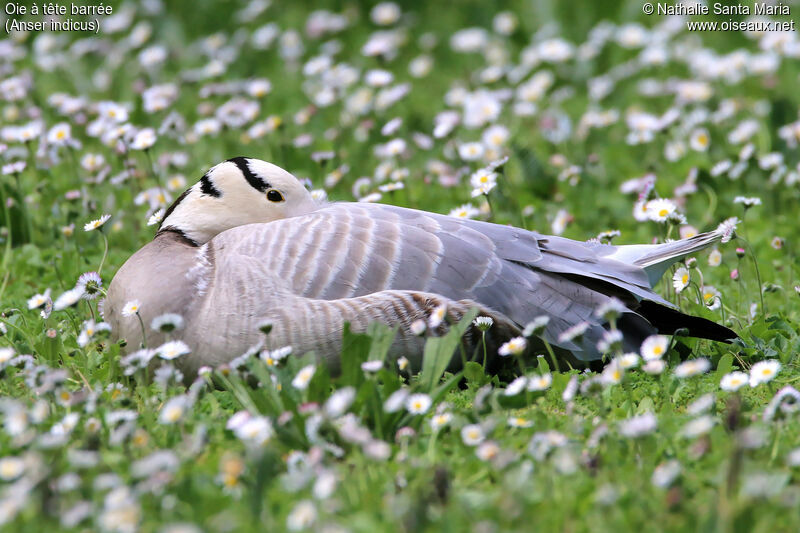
[[105, 158, 735, 372]]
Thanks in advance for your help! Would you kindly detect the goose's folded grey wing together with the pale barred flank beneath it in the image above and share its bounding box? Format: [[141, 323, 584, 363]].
[[206, 203, 670, 360]]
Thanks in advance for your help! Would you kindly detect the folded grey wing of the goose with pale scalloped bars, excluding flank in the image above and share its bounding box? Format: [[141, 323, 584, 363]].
[[218, 203, 668, 358]]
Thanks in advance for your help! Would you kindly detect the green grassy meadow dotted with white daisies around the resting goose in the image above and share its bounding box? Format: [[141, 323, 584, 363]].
[[0, 0, 800, 533]]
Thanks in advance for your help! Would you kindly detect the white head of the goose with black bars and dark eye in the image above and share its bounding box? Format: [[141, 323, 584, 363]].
[[159, 157, 319, 244]]
